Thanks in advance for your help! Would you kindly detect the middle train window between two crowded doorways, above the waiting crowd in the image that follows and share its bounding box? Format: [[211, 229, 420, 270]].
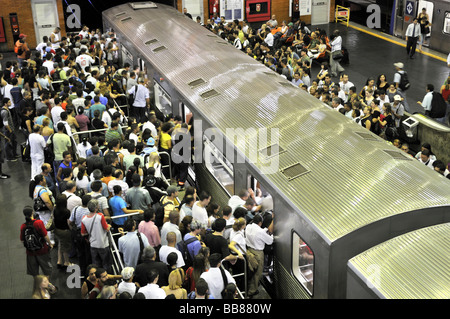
[[203, 136, 234, 196]]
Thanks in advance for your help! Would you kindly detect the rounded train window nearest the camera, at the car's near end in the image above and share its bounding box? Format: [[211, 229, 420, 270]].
[[292, 232, 314, 295]]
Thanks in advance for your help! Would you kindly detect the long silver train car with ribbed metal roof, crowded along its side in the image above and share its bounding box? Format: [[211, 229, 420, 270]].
[[103, 3, 450, 299]]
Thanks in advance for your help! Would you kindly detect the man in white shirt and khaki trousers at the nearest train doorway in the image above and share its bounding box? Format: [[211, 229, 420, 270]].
[[245, 215, 273, 297]]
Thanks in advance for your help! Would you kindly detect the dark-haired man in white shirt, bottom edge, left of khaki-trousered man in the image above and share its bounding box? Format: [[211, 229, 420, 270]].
[[200, 253, 236, 299]]
